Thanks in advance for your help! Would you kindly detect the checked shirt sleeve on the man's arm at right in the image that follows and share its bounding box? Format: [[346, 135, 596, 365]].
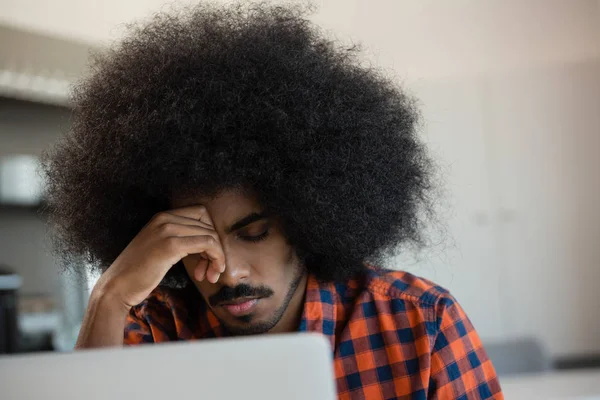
[[428, 296, 504, 400]]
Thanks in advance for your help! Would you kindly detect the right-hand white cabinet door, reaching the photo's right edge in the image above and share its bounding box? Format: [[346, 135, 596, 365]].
[[484, 59, 600, 353]]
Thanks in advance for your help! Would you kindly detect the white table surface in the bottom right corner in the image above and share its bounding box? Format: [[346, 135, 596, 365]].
[[500, 369, 600, 400]]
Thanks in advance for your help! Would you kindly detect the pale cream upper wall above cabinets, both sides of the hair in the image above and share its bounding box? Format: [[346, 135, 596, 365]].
[[0, 0, 600, 81]]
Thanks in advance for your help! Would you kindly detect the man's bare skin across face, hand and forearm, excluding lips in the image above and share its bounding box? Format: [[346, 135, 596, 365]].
[[76, 189, 307, 348]]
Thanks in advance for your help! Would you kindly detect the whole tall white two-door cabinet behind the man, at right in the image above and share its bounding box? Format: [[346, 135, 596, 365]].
[[396, 60, 600, 356]]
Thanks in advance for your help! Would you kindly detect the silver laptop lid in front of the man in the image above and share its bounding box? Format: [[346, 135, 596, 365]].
[[0, 333, 336, 400]]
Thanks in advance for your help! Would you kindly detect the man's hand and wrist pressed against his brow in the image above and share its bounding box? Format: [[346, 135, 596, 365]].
[[94, 206, 225, 308]]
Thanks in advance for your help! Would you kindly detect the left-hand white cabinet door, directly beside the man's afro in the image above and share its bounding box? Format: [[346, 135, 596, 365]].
[[398, 78, 509, 340]]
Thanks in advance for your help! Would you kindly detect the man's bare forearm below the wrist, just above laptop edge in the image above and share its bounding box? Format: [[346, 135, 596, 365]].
[[75, 289, 129, 349]]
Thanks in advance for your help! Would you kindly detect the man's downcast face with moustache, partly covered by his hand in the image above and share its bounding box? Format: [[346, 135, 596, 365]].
[[172, 190, 306, 334]]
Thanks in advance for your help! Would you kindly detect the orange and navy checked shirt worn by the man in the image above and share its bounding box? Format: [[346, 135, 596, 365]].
[[125, 268, 503, 400]]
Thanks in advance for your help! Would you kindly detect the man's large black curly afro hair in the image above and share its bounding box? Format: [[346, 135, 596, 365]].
[[42, 3, 433, 287]]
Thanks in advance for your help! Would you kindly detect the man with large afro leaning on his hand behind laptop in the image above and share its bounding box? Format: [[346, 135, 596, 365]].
[[44, 4, 502, 399]]
